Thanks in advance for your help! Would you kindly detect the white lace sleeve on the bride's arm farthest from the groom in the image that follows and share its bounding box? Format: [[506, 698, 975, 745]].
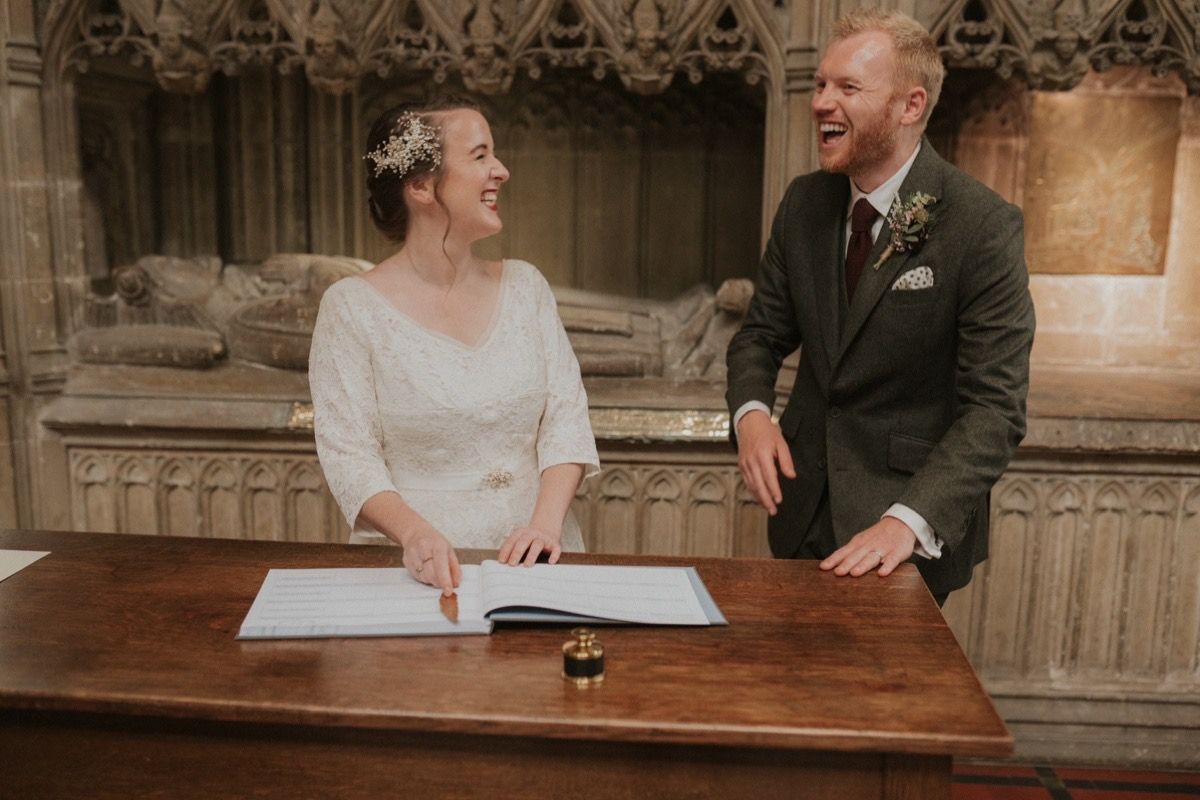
[[308, 278, 396, 529]]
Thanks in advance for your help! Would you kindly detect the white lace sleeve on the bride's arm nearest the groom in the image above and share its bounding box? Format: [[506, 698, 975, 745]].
[[535, 272, 600, 477]]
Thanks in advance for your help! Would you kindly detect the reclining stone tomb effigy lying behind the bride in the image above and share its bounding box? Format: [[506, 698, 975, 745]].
[[71, 253, 752, 383]]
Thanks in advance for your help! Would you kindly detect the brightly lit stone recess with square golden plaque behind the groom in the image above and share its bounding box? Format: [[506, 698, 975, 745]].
[[930, 67, 1200, 374]]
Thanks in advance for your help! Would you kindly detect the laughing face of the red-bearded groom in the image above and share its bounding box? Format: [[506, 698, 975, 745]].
[[812, 31, 904, 179]]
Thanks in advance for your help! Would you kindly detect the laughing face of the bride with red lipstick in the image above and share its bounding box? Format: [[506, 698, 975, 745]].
[[437, 108, 509, 241]]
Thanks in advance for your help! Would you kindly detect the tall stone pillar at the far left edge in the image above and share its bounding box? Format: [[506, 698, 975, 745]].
[[0, 0, 76, 528]]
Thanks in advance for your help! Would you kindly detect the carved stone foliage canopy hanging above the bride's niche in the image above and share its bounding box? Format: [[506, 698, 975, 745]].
[[44, 0, 782, 95]]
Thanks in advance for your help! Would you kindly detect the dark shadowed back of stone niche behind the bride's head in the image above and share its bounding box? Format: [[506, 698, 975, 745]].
[[79, 59, 766, 300]]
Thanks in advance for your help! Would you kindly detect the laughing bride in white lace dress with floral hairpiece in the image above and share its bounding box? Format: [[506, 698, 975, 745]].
[[308, 101, 599, 594]]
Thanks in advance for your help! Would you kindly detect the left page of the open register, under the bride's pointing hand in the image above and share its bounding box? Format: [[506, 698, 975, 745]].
[[238, 565, 492, 639]]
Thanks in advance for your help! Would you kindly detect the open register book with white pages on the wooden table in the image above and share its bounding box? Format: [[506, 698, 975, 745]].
[[238, 561, 726, 639]]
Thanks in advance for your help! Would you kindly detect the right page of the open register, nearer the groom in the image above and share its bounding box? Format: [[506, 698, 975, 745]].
[[481, 561, 709, 625]]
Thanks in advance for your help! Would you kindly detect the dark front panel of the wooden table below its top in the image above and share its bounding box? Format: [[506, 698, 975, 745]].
[[0, 712, 883, 800]]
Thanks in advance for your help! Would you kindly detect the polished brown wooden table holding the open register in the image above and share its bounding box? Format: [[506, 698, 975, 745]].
[[0, 531, 1012, 800]]
